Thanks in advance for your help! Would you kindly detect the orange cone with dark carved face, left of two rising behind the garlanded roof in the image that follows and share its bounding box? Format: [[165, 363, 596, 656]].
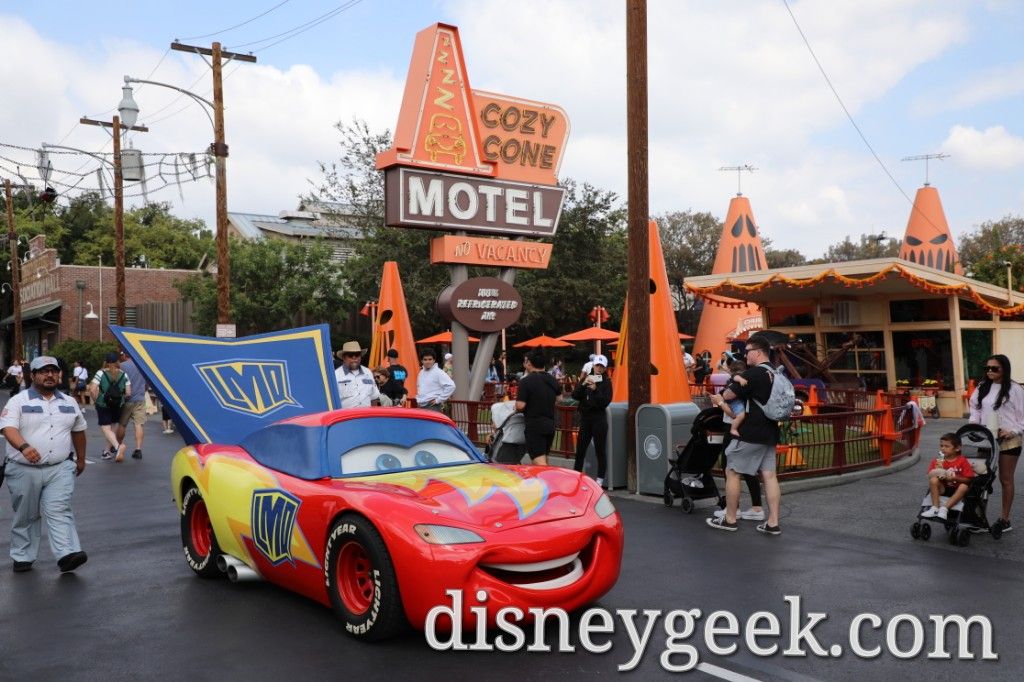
[[693, 196, 768, 364]]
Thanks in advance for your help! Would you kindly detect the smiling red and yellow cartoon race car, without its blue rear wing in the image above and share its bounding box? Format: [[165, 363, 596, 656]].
[[171, 408, 623, 640]]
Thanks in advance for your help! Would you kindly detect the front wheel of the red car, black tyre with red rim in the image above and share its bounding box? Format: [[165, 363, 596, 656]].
[[324, 515, 406, 641]]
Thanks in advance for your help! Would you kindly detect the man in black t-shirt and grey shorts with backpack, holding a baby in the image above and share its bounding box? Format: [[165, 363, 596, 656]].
[[707, 334, 782, 536]]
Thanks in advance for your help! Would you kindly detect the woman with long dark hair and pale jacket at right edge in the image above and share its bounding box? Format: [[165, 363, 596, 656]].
[[969, 355, 1024, 532]]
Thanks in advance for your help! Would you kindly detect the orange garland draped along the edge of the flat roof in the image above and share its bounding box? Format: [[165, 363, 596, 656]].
[[686, 264, 1024, 317]]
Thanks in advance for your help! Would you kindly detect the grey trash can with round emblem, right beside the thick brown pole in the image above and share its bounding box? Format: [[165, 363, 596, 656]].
[[637, 402, 700, 496]]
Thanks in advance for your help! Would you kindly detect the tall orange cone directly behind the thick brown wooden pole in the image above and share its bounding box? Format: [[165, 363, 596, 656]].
[[611, 220, 690, 404]]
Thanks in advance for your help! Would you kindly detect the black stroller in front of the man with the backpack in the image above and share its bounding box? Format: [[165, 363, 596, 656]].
[[665, 408, 729, 514]]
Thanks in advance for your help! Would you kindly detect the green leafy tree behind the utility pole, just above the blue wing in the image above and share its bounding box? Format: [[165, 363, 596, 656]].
[[176, 239, 344, 336]]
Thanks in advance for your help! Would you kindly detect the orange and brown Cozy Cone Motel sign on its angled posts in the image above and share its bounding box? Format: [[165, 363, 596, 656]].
[[377, 24, 569, 400]]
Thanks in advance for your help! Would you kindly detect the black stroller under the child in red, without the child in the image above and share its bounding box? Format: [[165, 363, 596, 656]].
[[910, 424, 1002, 547]]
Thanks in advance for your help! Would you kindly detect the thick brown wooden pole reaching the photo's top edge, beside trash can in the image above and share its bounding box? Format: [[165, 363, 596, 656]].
[[626, 0, 650, 489]]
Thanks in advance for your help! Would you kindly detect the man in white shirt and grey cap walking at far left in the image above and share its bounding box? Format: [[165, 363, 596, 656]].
[[0, 355, 88, 572]]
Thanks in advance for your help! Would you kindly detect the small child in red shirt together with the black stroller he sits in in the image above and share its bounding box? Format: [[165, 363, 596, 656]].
[[910, 424, 1002, 547]]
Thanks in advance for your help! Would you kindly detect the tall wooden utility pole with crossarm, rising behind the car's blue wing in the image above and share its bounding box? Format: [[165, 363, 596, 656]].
[[171, 41, 256, 337]]
